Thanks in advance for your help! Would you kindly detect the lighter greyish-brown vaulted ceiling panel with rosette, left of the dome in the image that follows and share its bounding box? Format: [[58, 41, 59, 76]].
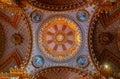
[[0, 7, 32, 71]]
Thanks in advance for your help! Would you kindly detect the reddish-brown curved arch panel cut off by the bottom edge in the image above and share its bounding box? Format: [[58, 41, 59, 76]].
[[32, 66, 93, 79]]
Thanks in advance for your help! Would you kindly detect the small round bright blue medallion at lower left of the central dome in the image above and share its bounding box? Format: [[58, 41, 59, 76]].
[[32, 55, 44, 68]]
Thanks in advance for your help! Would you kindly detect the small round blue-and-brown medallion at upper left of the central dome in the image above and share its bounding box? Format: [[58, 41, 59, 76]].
[[31, 11, 42, 23]]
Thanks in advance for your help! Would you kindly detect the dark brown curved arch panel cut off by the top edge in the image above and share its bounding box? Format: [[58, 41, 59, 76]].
[[28, 0, 87, 11]]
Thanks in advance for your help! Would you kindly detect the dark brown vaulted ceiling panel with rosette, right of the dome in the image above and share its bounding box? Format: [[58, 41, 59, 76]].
[[89, 9, 120, 72]]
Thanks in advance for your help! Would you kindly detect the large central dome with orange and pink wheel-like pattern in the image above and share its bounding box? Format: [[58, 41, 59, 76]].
[[38, 17, 82, 61]]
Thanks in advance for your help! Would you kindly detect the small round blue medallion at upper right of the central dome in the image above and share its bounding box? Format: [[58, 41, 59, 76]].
[[77, 10, 89, 21]]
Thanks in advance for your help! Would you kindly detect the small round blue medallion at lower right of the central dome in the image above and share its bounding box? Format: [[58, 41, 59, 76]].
[[77, 55, 89, 67]]
